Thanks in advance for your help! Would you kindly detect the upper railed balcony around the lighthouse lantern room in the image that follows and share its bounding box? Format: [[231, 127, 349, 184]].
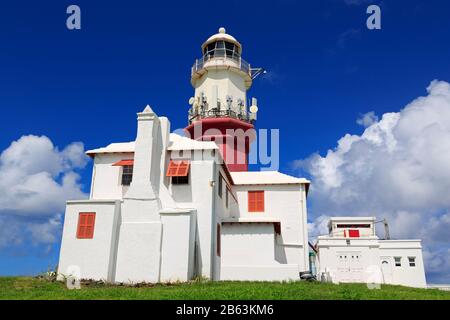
[[191, 49, 252, 78]]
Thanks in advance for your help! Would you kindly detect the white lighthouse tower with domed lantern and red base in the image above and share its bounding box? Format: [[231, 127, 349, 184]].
[[185, 28, 263, 172]]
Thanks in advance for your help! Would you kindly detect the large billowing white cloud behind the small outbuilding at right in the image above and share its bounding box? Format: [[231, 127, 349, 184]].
[[295, 81, 450, 282]]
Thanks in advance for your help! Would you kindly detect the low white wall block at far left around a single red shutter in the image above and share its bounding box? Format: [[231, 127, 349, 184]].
[[58, 200, 120, 281]]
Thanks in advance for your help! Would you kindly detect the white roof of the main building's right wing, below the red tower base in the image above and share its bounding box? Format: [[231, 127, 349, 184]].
[[230, 171, 310, 185]]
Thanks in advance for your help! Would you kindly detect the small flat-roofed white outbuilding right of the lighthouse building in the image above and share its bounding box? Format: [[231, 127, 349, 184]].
[[316, 217, 426, 288]]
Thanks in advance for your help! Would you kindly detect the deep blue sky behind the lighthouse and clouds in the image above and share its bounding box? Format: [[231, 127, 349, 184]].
[[0, 0, 450, 281]]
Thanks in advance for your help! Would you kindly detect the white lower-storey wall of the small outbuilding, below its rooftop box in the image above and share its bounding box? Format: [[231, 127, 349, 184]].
[[317, 236, 426, 288]]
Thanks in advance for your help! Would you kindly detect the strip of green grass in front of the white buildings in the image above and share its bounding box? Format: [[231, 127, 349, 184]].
[[0, 277, 450, 300]]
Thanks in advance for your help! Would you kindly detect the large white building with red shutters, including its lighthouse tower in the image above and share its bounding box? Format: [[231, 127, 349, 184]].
[[58, 28, 309, 282]]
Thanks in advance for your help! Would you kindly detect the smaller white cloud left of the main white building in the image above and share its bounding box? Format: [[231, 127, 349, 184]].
[[0, 135, 87, 248]]
